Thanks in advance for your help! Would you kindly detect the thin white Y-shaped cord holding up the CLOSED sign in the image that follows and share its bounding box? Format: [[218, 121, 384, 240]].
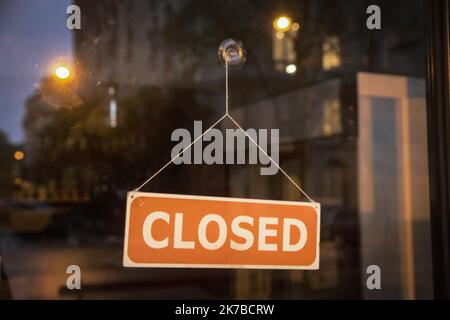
[[134, 60, 315, 203]]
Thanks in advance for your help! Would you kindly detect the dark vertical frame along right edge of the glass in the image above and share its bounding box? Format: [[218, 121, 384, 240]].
[[425, 0, 450, 299]]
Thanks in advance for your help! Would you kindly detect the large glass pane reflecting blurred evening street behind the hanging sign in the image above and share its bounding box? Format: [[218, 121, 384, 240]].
[[0, 0, 440, 299]]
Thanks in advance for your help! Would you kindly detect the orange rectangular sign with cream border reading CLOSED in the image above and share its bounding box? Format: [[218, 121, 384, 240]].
[[123, 192, 320, 269]]
